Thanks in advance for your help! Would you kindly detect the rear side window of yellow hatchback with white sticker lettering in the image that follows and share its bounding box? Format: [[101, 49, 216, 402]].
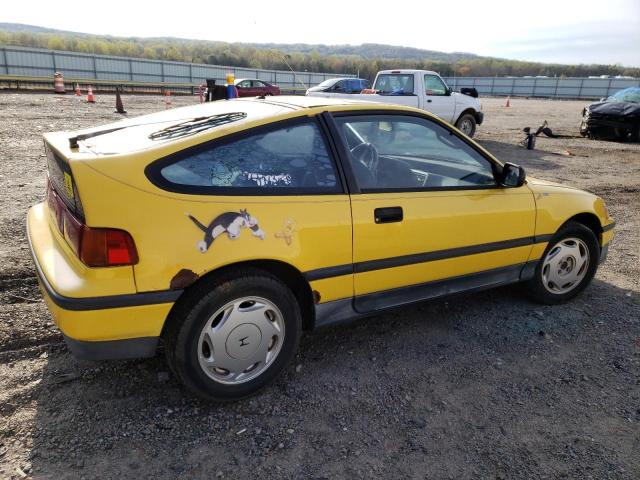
[[159, 121, 340, 194]]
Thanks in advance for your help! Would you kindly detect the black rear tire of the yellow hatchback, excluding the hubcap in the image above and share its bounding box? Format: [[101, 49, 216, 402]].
[[164, 268, 302, 401]]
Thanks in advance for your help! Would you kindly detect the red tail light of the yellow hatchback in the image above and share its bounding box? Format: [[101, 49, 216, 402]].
[[47, 179, 138, 267]]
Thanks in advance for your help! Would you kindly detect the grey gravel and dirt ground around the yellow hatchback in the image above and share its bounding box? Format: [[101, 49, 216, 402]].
[[0, 94, 640, 480]]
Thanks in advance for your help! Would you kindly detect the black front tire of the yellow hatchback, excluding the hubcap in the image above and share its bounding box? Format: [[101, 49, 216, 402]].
[[524, 222, 600, 305]]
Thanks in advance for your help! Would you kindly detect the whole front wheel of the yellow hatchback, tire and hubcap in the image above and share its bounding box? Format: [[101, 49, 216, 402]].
[[525, 222, 600, 305]]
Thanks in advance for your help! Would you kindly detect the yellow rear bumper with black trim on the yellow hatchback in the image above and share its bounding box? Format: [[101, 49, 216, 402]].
[[27, 204, 182, 360]]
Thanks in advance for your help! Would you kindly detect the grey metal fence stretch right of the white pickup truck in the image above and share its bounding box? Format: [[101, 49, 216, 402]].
[[445, 77, 640, 99]]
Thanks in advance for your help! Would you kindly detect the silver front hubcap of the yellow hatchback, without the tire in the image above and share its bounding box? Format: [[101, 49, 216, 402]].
[[542, 238, 589, 294]]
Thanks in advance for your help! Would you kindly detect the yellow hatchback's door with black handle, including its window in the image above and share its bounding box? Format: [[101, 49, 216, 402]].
[[334, 111, 535, 312]]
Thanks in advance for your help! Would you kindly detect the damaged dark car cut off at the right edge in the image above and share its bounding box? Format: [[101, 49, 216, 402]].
[[580, 87, 640, 142]]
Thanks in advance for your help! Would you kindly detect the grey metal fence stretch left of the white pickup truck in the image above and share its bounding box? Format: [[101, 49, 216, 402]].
[[0, 46, 349, 90]]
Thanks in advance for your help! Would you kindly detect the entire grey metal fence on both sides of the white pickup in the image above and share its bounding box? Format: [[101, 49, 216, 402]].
[[0, 46, 640, 99]]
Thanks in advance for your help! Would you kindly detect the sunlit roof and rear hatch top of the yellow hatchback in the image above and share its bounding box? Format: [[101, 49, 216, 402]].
[[45, 96, 384, 159]]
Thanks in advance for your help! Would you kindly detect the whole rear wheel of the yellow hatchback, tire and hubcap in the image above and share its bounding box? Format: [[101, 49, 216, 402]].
[[165, 270, 302, 400]]
